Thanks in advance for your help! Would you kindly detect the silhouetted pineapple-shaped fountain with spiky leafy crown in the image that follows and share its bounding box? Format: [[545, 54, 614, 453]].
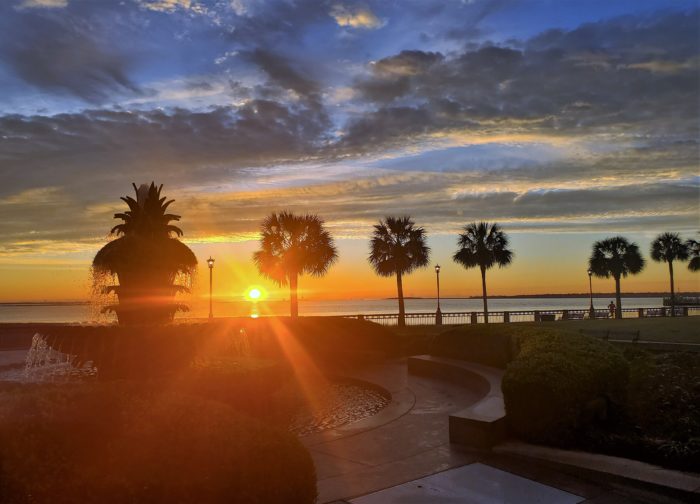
[[92, 182, 197, 325]]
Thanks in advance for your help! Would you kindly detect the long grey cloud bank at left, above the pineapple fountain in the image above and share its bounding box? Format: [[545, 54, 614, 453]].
[[0, 100, 326, 202]]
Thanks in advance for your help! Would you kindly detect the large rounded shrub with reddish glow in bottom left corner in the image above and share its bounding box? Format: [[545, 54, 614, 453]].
[[0, 382, 316, 504]]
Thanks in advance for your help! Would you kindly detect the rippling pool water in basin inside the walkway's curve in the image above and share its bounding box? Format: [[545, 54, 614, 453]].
[[290, 382, 389, 436]]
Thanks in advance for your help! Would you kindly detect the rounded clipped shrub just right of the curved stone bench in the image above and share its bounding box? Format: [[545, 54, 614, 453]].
[[502, 333, 629, 446]]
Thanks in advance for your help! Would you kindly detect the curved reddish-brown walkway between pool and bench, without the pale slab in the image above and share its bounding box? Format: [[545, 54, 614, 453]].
[[301, 360, 479, 503]]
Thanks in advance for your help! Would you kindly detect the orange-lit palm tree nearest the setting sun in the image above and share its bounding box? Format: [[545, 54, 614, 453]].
[[253, 211, 338, 317]]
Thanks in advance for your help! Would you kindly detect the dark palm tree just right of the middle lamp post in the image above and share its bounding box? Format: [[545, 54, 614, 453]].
[[452, 222, 513, 323]]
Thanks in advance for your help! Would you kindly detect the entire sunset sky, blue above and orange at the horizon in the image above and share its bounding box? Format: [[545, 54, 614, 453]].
[[0, 0, 700, 301]]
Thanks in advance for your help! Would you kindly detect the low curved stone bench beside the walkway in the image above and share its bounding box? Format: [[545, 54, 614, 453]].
[[408, 355, 506, 448]]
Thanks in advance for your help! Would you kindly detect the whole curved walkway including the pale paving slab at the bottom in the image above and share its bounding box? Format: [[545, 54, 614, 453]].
[[301, 360, 692, 504]]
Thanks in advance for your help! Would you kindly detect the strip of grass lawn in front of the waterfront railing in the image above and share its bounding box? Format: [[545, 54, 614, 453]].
[[392, 317, 700, 344]]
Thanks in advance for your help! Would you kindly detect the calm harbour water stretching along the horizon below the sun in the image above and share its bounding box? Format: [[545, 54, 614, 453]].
[[0, 296, 663, 323]]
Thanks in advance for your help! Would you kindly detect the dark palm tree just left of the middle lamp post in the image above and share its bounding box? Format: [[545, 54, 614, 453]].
[[367, 216, 430, 327]]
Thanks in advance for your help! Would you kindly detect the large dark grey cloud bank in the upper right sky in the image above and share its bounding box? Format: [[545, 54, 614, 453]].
[[343, 10, 700, 149]]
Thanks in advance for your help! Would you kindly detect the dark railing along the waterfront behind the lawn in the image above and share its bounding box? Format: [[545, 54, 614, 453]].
[[344, 306, 700, 326]]
